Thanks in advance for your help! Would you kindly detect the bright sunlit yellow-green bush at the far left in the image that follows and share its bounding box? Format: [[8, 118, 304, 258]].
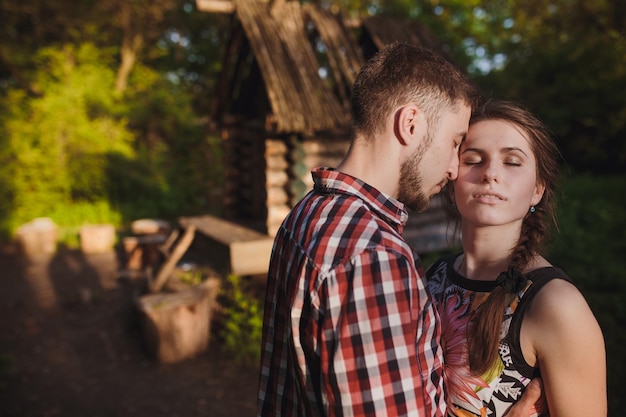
[[0, 44, 132, 235]]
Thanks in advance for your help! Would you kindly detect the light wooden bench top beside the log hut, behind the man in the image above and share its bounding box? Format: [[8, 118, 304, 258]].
[[178, 215, 274, 275]]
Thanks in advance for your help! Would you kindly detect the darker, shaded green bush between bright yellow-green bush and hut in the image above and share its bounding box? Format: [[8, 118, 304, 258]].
[[109, 65, 221, 218]]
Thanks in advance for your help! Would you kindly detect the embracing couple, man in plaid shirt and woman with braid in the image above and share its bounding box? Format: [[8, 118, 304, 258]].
[[257, 43, 606, 416]]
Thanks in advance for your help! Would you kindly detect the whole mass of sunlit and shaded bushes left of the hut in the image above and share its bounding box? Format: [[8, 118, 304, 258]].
[[0, 44, 221, 240]]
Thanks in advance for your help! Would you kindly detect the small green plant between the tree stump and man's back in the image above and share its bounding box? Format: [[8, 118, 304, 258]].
[[220, 274, 263, 366]]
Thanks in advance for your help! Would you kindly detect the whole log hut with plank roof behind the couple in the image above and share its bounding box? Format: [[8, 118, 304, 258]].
[[196, 0, 458, 251]]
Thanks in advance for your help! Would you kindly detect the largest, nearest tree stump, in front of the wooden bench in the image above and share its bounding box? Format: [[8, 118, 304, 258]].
[[138, 278, 220, 363]]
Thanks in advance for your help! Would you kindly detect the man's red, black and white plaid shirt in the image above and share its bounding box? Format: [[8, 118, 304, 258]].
[[257, 168, 446, 417]]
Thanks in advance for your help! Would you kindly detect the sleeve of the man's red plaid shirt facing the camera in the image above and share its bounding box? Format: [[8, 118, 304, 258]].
[[318, 250, 430, 416]]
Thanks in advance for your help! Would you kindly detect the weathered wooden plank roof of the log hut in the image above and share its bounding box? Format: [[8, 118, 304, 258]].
[[197, 0, 446, 133]]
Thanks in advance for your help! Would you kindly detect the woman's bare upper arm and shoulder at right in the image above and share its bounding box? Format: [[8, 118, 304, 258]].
[[521, 279, 607, 417]]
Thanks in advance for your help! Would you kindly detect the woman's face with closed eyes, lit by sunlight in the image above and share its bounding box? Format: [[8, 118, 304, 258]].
[[454, 120, 544, 226]]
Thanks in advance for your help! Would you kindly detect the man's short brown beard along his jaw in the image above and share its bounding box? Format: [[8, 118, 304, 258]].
[[398, 135, 431, 211]]
